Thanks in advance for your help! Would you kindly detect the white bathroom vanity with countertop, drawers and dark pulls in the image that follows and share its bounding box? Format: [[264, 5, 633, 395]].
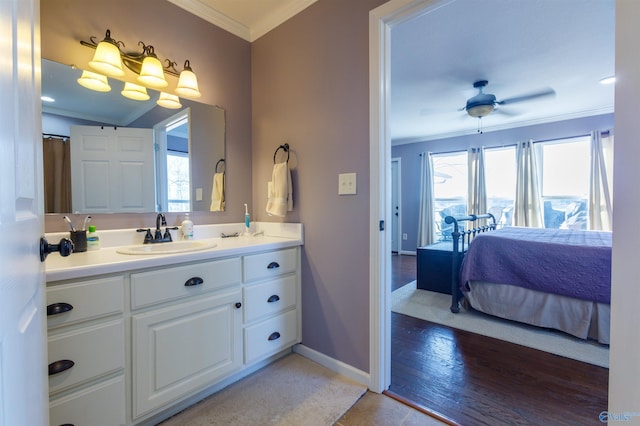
[[45, 223, 303, 426]]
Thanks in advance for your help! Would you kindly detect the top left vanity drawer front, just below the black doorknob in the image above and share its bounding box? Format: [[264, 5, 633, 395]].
[[47, 276, 124, 328]]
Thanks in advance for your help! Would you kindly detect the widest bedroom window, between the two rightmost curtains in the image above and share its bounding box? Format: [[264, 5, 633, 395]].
[[539, 137, 590, 229]]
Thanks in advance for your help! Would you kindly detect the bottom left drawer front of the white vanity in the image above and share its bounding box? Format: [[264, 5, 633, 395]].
[[49, 376, 127, 426]]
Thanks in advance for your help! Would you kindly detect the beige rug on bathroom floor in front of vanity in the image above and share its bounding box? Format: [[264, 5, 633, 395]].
[[162, 354, 367, 426]]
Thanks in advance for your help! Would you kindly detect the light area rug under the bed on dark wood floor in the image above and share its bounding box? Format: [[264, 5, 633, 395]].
[[391, 281, 609, 368]]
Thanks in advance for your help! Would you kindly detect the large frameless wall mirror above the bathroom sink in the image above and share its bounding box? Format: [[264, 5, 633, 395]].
[[42, 59, 226, 213]]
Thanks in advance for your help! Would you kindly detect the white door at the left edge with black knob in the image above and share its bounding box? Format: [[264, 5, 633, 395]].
[[0, 0, 49, 426]]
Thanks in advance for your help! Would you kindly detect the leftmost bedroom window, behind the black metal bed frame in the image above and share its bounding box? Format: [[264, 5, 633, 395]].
[[433, 151, 468, 240]]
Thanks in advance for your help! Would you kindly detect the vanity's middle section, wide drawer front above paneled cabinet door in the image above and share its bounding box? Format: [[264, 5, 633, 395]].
[[131, 258, 242, 417]]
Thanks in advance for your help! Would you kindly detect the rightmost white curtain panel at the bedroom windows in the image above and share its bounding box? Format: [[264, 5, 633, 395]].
[[589, 131, 613, 231]]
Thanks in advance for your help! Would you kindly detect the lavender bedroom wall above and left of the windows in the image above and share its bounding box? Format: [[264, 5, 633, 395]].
[[391, 114, 613, 252]]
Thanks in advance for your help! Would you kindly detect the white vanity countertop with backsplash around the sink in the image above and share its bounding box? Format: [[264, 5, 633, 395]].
[[45, 223, 304, 282]]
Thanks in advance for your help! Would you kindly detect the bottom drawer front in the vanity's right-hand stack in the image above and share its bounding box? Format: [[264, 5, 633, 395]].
[[244, 310, 298, 364]]
